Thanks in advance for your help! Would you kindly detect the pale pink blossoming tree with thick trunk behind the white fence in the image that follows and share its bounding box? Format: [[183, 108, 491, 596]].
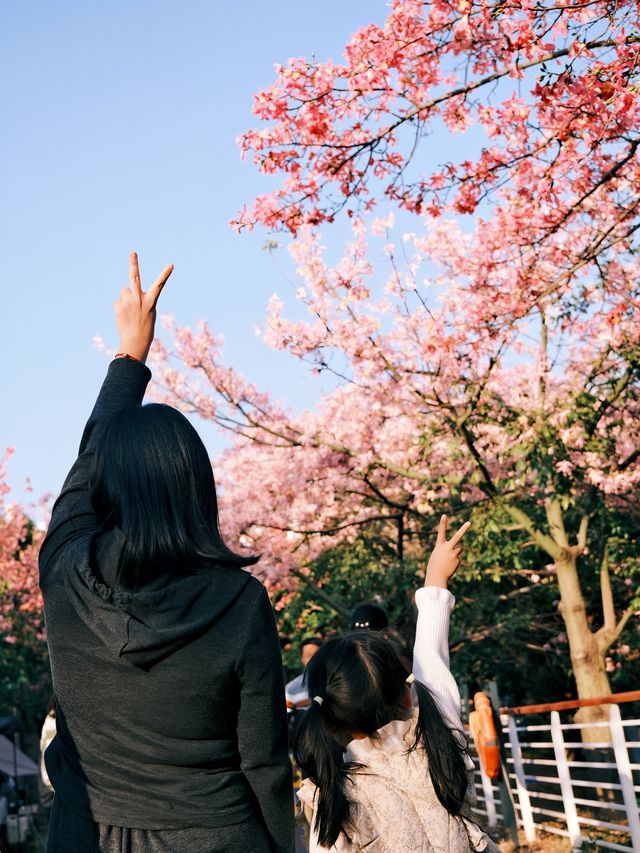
[[155, 211, 640, 724]]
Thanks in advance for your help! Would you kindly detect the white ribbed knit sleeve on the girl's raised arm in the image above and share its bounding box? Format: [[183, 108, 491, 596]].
[[413, 586, 462, 729]]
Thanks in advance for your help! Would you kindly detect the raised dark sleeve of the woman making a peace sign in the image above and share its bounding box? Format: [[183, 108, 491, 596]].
[[40, 358, 151, 579]]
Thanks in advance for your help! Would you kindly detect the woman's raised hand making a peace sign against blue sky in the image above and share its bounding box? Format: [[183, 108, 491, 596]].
[[113, 252, 173, 362]]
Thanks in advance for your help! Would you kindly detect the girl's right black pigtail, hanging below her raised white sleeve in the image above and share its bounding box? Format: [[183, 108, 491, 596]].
[[411, 681, 468, 815]]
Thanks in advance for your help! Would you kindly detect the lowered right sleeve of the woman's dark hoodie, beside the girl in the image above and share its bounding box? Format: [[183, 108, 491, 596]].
[[238, 585, 295, 853]]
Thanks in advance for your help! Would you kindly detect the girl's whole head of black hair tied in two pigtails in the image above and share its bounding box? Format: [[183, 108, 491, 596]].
[[293, 631, 467, 847]]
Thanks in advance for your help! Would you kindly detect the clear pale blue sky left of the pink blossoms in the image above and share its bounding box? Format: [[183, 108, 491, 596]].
[[0, 0, 388, 506]]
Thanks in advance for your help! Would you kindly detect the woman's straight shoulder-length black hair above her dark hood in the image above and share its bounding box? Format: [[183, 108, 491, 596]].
[[89, 403, 258, 588]]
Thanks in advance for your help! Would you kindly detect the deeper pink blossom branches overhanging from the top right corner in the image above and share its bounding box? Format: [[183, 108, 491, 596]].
[[234, 0, 640, 243]]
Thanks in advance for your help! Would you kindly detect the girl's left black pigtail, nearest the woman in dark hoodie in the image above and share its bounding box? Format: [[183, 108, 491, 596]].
[[293, 701, 351, 847]]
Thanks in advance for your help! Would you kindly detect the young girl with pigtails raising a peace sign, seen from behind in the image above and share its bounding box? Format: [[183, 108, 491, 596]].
[[294, 516, 498, 853]]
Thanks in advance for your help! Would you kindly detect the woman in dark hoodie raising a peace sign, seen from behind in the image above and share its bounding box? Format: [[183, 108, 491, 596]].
[[40, 253, 294, 853]]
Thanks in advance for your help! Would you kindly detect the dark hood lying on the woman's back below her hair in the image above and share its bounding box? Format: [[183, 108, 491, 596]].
[[63, 534, 252, 669]]
